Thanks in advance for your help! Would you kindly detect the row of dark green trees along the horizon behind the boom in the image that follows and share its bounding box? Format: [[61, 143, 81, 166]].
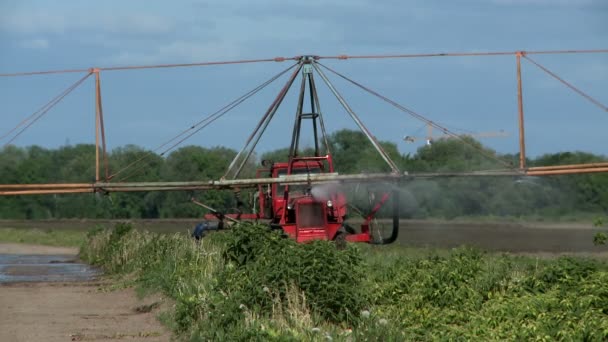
[[0, 130, 608, 219]]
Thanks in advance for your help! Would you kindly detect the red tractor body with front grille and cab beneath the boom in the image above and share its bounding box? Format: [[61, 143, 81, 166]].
[[205, 155, 398, 243]]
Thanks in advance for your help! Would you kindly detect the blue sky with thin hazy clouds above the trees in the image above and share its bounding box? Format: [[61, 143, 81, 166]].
[[0, 0, 608, 157]]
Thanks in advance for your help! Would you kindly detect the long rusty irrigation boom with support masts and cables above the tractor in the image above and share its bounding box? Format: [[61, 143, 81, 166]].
[[0, 49, 608, 196]]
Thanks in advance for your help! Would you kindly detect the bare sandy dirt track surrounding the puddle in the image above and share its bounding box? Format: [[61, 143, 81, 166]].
[[0, 244, 171, 341]]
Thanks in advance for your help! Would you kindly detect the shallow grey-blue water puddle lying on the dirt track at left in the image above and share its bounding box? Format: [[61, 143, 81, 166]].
[[0, 254, 100, 283]]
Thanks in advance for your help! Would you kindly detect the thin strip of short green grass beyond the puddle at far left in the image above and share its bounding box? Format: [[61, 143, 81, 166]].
[[0, 228, 87, 247]]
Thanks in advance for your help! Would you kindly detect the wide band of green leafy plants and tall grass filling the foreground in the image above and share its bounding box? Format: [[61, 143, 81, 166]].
[[81, 224, 608, 341]]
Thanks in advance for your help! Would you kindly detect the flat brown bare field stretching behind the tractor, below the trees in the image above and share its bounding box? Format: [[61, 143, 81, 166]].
[[0, 219, 608, 253]]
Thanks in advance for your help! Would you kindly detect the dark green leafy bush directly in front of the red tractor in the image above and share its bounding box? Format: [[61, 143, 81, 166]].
[[204, 223, 365, 332]]
